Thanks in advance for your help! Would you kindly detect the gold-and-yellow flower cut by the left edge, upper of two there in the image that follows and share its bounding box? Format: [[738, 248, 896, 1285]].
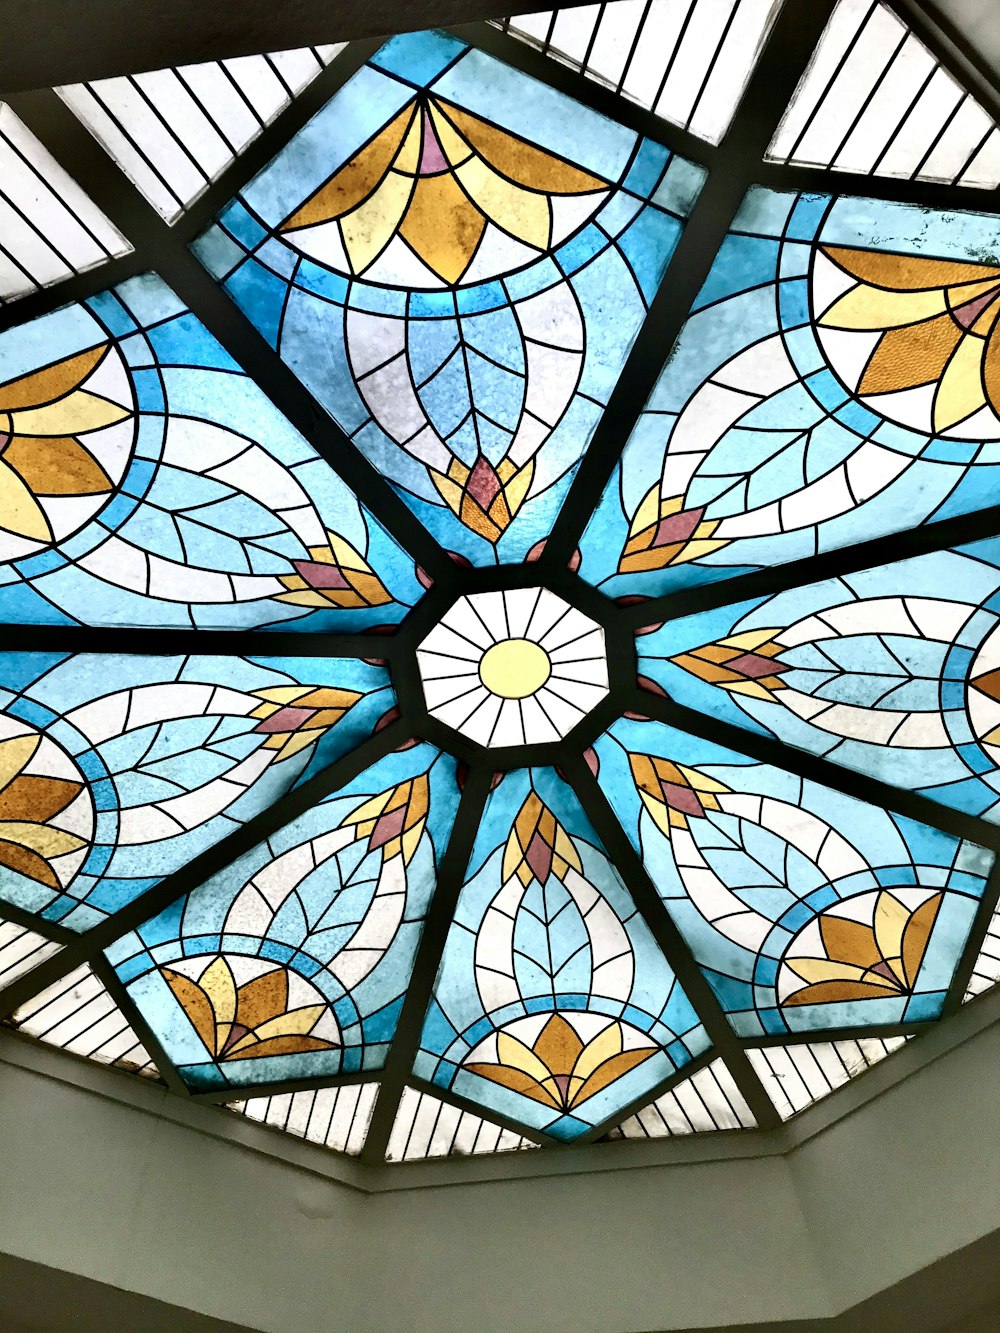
[[0, 343, 131, 543]]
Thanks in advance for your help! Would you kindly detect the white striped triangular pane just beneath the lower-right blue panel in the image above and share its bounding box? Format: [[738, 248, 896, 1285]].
[[747, 1037, 909, 1120]]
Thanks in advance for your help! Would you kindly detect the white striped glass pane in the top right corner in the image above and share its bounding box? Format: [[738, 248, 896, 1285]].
[[768, 0, 1000, 189]]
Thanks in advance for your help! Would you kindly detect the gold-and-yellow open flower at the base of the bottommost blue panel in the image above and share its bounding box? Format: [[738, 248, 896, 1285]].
[[464, 1013, 659, 1112]]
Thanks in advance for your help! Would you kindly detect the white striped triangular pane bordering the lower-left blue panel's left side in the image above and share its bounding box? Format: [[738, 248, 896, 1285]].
[[11, 964, 157, 1078]]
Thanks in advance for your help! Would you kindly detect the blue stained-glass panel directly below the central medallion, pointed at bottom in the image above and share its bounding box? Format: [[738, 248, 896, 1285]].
[[413, 769, 708, 1141]]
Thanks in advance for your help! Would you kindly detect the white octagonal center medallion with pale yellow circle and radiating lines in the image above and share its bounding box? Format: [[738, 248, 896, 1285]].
[[417, 588, 608, 749]]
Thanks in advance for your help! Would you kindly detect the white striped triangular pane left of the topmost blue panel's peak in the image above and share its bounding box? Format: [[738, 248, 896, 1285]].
[[56, 44, 343, 221]]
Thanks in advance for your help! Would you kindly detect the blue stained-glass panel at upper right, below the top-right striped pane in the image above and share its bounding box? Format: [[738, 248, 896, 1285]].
[[581, 188, 1000, 596]]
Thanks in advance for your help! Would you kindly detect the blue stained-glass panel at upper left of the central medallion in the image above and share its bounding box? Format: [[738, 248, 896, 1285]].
[[0, 275, 423, 631]]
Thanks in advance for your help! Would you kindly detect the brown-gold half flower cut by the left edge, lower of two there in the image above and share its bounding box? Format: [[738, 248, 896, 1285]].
[[0, 736, 85, 889]]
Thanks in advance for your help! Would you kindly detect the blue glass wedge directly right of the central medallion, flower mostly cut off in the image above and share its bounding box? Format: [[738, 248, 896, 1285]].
[[636, 539, 1000, 821]]
